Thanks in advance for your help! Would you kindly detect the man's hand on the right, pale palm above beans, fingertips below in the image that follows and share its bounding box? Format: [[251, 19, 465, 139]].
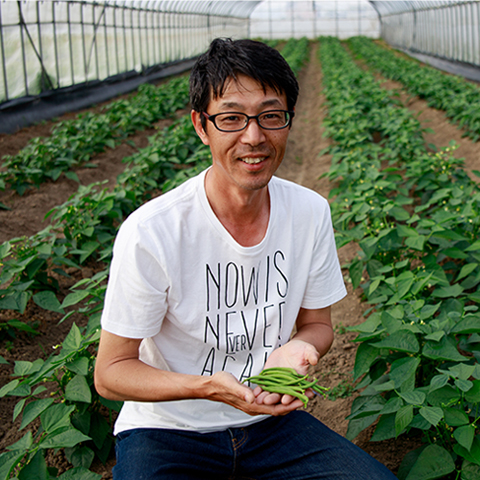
[[254, 338, 320, 408]]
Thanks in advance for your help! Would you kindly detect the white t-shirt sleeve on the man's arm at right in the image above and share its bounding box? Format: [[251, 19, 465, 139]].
[[302, 198, 347, 309]]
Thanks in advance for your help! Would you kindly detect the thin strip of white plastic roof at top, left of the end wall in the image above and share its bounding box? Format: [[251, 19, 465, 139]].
[[101, 0, 262, 18]]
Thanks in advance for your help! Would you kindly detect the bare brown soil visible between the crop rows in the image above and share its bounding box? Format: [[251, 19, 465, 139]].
[[0, 43, 480, 479]]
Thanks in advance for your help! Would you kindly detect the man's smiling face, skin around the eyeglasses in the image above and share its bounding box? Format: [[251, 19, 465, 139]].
[[192, 75, 290, 194]]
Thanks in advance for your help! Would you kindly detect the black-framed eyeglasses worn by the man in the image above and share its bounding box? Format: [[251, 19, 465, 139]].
[[202, 110, 295, 132]]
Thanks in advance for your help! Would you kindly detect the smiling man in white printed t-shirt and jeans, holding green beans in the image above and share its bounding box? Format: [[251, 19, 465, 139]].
[[95, 39, 395, 480]]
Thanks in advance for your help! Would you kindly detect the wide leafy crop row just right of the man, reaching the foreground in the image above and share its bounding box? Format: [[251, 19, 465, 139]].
[[320, 38, 480, 480]]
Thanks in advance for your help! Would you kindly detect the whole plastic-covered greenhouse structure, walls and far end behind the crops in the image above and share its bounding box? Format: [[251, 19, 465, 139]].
[[0, 0, 480, 131]]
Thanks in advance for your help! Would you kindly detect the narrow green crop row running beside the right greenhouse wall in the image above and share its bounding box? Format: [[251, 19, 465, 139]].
[[349, 37, 480, 141]]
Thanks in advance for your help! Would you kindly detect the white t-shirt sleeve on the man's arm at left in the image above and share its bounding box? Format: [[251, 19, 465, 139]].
[[101, 219, 169, 338]]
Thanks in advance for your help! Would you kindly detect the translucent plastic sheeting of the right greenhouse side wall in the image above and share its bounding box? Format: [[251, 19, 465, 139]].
[[370, 0, 480, 67]]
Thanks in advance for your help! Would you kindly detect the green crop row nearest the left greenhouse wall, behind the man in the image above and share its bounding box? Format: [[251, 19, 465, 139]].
[[0, 76, 188, 195]]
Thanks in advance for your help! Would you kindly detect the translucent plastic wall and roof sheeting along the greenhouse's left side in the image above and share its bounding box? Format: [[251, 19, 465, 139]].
[[0, 0, 259, 104]]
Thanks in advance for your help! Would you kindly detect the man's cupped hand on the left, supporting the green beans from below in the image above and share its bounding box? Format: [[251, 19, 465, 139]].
[[207, 372, 303, 416]]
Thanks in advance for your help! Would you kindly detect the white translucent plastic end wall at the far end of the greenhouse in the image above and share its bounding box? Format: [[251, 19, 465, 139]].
[[250, 0, 380, 39]]
